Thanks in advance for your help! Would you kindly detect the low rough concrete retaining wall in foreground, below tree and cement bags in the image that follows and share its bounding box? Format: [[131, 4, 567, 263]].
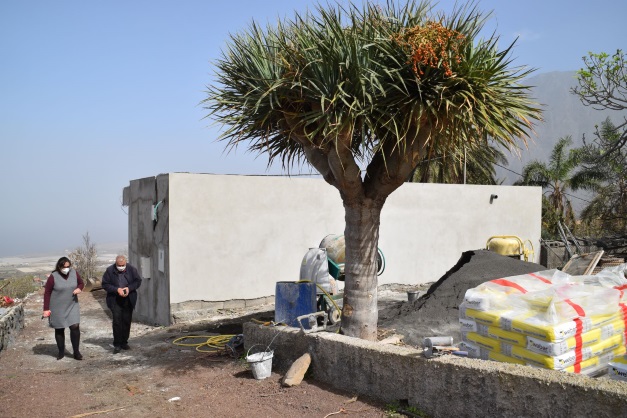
[[244, 323, 627, 418]]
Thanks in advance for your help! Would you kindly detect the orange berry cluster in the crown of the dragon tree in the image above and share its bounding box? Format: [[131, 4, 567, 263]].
[[394, 21, 465, 78]]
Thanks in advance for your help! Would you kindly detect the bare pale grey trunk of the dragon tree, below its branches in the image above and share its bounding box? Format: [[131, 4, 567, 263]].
[[342, 199, 383, 341]]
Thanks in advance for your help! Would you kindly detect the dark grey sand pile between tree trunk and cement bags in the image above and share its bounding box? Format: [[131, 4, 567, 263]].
[[379, 250, 546, 347]]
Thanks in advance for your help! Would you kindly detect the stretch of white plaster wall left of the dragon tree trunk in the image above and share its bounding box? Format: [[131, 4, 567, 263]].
[[169, 173, 344, 303]]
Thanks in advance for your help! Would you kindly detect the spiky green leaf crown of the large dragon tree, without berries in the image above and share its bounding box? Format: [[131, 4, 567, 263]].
[[203, 1, 540, 180]]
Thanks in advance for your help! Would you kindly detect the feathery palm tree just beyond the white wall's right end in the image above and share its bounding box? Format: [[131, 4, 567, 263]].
[[514, 136, 604, 236]]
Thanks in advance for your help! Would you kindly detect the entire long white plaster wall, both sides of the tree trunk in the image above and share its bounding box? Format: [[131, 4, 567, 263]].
[[169, 173, 541, 303]]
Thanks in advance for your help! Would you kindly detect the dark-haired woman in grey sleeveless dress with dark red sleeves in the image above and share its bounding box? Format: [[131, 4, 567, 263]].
[[43, 257, 85, 360]]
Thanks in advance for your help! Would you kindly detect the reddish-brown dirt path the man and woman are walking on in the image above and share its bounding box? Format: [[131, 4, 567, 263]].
[[0, 291, 385, 418]]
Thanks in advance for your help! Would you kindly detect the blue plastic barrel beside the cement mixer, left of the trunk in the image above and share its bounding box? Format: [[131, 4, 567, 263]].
[[274, 282, 316, 329]]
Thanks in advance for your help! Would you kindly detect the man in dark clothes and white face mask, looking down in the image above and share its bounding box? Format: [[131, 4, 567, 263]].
[[102, 255, 142, 354]]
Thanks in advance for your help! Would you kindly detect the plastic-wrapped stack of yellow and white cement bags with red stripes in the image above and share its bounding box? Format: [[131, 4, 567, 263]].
[[460, 270, 627, 374]]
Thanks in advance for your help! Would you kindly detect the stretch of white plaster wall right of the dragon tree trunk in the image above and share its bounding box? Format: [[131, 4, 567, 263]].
[[379, 183, 542, 284]]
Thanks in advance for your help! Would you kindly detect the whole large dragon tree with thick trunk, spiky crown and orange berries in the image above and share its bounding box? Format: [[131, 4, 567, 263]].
[[203, 0, 540, 340]]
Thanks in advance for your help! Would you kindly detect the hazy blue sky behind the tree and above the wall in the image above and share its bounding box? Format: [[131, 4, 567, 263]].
[[0, 0, 627, 256]]
